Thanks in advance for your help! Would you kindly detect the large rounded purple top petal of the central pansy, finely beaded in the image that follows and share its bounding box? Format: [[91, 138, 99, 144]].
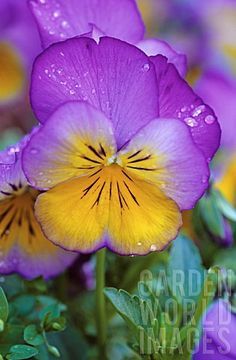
[[31, 37, 158, 147]]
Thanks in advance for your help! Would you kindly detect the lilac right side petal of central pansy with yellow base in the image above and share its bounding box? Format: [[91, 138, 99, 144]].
[[119, 119, 209, 210]]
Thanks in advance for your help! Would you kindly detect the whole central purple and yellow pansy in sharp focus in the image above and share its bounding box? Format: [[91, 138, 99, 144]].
[[23, 37, 220, 254]]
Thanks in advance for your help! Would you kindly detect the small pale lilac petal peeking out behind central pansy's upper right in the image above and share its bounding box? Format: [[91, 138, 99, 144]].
[[136, 39, 187, 77]]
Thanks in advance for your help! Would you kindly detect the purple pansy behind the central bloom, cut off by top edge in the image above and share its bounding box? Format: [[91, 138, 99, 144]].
[[29, 0, 187, 76]]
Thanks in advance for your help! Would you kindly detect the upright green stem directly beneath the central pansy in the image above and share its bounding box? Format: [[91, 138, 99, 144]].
[[96, 248, 107, 359]]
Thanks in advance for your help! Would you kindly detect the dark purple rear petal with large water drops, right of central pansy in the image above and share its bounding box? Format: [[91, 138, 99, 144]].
[[151, 55, 220, 160]]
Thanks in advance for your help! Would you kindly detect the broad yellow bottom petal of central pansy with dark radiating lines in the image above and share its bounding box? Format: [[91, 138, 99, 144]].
[[36, 164, 182, 254]]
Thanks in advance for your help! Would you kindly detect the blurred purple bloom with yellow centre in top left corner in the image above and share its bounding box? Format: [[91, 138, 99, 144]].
[[0, 0, 40, 107]]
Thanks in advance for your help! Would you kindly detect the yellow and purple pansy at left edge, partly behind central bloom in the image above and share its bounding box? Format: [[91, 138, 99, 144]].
[[0, 139, 76, 279]]
